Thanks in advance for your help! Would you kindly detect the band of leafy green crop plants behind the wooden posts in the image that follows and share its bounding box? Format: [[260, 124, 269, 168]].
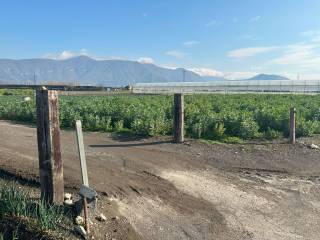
[[0, 94, 320, 140]]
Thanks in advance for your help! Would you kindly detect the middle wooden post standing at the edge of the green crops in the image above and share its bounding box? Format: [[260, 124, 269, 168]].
[[173, 93, 184, 143]]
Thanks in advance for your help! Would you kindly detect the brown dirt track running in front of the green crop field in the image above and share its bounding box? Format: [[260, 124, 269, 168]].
[[0, 121, 320, 240]]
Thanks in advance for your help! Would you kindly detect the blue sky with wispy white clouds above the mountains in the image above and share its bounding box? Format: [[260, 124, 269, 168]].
[[0, 0, 320, 79]]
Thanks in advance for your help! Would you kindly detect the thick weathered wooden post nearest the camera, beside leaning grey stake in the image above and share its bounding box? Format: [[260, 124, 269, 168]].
[[36, 89, 64, 204]]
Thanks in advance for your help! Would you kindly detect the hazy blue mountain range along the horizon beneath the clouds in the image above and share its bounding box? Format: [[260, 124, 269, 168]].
[[0, 56, 283, 87]]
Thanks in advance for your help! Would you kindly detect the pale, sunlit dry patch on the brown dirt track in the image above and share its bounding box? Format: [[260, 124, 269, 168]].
[[161, 170, 320, 240]]
